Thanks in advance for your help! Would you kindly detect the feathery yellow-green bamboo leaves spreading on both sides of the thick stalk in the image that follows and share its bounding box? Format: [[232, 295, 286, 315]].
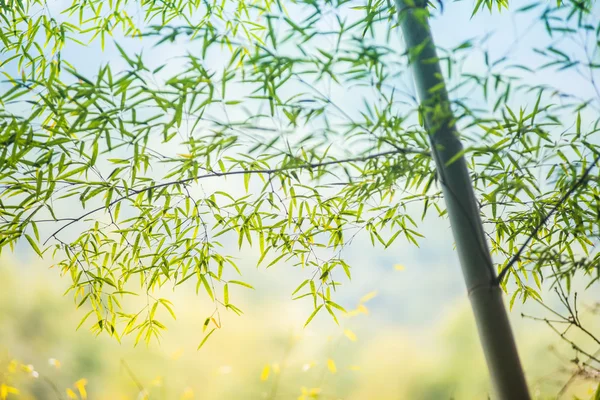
[[0, 0, 600, 354]]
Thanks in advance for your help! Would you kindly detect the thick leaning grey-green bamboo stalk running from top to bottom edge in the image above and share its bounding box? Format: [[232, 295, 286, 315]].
[[396, 0, 530, 400]]
